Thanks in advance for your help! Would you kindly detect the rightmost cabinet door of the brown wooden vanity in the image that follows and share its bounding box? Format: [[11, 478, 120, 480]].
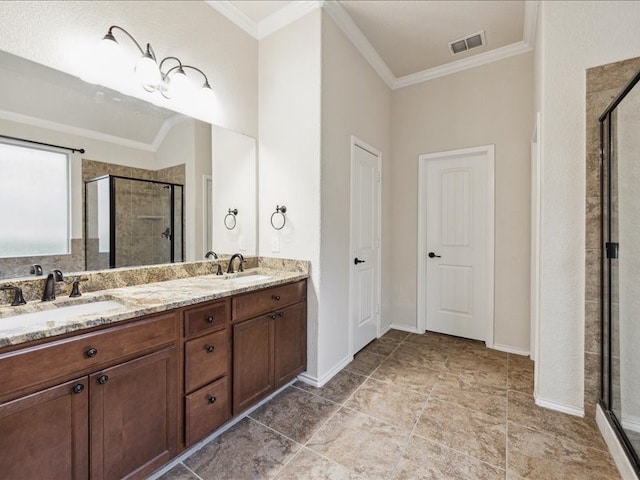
[[274, 303, 307, 388]]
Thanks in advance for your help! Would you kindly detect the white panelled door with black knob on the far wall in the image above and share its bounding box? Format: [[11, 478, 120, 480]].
[[425, 149, 493, 342]]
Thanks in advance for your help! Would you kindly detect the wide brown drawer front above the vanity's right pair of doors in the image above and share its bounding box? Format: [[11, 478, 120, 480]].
[[232, 280, 307, 322]]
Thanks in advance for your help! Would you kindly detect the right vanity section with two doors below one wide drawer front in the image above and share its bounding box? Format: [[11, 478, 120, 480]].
[[232, 280, 307, 415]]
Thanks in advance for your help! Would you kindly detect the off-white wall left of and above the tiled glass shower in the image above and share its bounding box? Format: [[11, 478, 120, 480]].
[[535, 1, 640, 414]]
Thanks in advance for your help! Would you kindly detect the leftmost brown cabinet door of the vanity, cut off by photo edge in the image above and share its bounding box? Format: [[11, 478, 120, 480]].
[[0, 377, 89, 480]]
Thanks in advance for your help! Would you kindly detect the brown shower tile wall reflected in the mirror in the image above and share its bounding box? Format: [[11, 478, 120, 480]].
[[82, 160, 185, 268]]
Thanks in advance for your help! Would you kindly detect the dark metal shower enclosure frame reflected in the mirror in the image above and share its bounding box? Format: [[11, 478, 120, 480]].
[[84, 174, 185, 270]]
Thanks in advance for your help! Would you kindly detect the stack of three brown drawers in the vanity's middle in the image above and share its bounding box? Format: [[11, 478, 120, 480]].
[[184, 298, 231, 447]]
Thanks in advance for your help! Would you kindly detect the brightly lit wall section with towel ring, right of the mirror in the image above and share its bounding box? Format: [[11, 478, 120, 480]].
[[258, 10, 321, 376]]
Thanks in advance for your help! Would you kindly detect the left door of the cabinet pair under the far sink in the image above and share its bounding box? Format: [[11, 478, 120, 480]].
[[233, 316, 274, 415]]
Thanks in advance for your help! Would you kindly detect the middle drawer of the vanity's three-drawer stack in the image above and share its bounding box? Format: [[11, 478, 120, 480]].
[[184, 329, 230, 392]]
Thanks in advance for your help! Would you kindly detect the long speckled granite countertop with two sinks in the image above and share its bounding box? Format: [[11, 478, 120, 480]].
[[0, 268, 309, 348]]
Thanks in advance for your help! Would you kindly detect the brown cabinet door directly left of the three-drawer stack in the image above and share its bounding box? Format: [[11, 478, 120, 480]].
[[90, 347, 178, 480]]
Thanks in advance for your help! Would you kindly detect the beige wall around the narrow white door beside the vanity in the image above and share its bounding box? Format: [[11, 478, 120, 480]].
[[319, 13, 392, 378]]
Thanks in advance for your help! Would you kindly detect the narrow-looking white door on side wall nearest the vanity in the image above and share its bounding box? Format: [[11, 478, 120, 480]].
[[350, 142, 380, 353]]
